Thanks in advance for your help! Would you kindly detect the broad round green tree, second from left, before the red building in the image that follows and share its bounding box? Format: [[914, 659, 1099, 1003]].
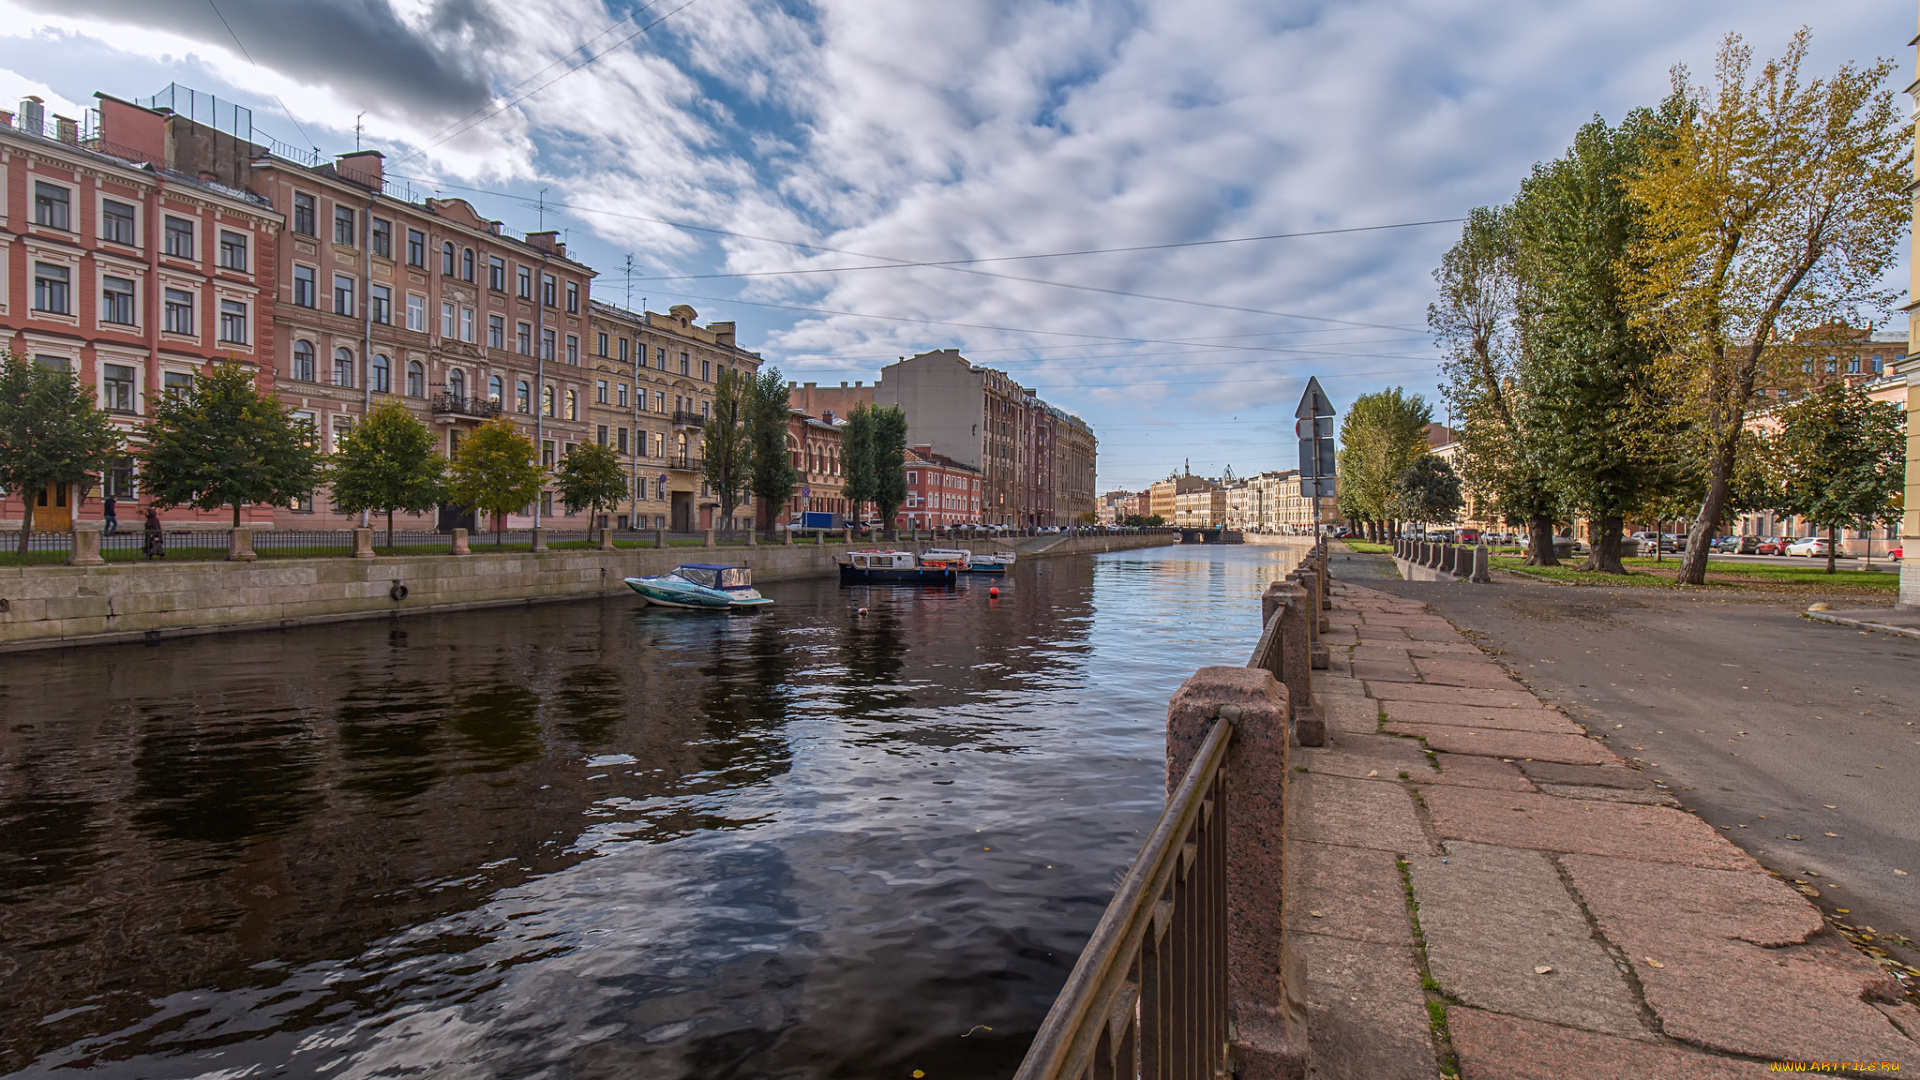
[[142, 361, 321, 528]]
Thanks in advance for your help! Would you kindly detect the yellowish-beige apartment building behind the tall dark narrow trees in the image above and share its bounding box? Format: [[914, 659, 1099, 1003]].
[[588, 300, 760, 532]]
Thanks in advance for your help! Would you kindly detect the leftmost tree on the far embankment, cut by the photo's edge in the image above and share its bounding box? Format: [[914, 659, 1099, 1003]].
[[0, 352, 123, 555]]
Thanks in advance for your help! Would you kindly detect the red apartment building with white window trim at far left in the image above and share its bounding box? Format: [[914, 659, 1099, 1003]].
[[0, 98, 280, 530]]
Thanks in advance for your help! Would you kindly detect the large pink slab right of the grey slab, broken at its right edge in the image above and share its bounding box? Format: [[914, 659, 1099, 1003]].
[[1563, 855, 1920, 1061]]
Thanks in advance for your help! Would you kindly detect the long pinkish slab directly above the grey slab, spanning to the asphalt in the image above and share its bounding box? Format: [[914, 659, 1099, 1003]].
[[1421, 786, 1761, 872]]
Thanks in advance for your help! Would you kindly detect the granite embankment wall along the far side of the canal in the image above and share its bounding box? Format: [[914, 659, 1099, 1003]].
[[0, 536, 1169, 651]]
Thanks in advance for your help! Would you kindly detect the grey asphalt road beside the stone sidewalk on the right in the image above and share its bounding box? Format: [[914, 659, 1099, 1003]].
[[1334, 557, 1920, 967]]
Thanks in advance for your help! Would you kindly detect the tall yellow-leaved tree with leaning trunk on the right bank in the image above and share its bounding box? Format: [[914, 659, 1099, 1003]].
[[1626, 29, 1912, 584]]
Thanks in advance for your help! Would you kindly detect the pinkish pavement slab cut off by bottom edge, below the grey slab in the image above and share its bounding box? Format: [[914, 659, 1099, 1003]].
[[1446, 1009, 1778, 1080]]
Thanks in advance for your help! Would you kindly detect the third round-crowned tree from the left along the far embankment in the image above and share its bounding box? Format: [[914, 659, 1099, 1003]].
[[326, 398, 447, 548]]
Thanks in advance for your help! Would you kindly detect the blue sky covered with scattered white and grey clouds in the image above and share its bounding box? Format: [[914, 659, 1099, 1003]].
[[0, 0, 1916, 490]]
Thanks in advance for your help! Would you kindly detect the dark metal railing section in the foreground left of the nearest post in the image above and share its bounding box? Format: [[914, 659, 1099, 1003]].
[[1014, 721, 1233, 1080]]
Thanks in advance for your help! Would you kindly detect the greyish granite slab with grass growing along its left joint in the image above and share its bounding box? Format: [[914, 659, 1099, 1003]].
[[1409, 842, 1651, 1038]]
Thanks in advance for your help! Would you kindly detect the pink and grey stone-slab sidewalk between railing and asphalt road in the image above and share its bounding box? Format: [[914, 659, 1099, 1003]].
[[1286, 582, 1920, 1080]]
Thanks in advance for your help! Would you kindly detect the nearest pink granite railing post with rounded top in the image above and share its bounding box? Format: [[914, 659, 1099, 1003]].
[[1167, 667, 1308, 1080]]
